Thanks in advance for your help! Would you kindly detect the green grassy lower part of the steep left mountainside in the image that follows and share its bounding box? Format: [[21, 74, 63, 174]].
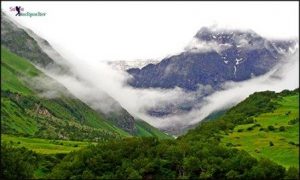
[[1, 47, 130, 140]]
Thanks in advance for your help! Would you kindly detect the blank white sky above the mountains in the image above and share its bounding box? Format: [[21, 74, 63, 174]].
[[1, 1, 299, 61]]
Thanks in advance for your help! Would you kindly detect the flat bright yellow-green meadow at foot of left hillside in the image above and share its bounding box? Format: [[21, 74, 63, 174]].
[[1, 134, 95, 154]]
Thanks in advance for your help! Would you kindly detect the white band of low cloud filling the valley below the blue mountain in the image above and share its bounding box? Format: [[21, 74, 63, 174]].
[[31, 31, 299, 133]]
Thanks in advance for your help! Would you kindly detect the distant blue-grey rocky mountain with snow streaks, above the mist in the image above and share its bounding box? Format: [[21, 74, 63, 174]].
[[127, 27, 298, 91]]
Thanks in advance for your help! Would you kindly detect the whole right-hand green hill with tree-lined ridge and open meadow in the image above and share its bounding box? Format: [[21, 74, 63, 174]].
[[184, 89, 299, 169]]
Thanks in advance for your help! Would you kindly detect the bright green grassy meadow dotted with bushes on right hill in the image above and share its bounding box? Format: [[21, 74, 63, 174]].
[[222, 94, 299, 167]]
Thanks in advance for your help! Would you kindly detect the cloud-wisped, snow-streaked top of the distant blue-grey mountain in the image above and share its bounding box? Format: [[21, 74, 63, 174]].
[[185, 27, 298, 58]]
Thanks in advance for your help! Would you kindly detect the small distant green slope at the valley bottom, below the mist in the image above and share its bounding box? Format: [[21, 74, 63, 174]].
[[136, 120, 172, 139]]
